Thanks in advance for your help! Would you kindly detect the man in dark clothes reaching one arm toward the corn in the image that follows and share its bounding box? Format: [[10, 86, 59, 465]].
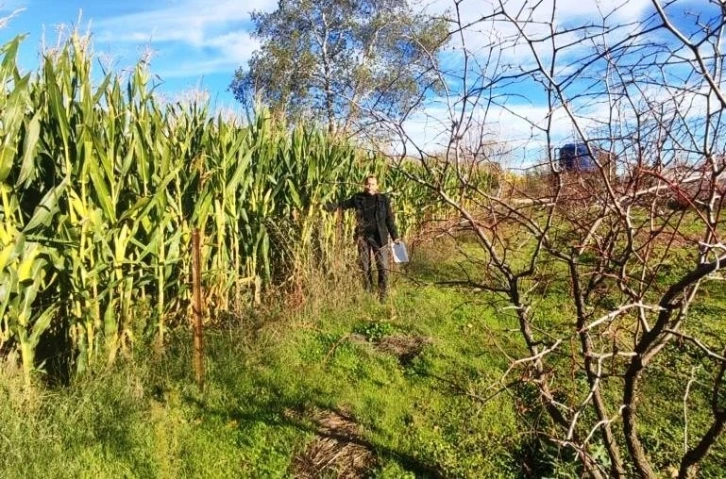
[[325, 175, 400, 302]]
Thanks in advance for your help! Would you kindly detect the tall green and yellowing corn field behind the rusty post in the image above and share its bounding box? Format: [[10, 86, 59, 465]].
[[0, 34, 464, 383]]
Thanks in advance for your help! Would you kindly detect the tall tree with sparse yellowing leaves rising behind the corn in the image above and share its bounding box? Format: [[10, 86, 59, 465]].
[[230, 0, 449, 139]]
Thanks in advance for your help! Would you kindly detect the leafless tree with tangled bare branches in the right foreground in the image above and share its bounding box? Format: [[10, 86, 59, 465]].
[[372, 0, 726, 478]]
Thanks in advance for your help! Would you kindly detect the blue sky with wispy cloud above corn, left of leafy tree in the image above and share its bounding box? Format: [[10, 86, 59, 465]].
[[0, 0, 276, 111]]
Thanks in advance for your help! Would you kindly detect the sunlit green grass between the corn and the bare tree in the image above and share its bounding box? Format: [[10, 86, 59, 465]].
[[0, 238, 726, 478]]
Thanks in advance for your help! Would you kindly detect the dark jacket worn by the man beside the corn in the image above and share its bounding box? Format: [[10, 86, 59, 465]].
[[326, 192, 398, 247]]
